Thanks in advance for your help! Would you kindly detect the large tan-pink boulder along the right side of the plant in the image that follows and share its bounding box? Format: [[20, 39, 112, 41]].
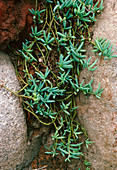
[[76, 0, 117, 170]]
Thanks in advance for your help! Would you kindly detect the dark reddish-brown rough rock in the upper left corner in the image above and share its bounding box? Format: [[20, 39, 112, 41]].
[[0, 0, 35, 49]]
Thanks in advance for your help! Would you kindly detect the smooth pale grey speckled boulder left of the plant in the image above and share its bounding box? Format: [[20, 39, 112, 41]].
[[0, 52, 27, 170]]
